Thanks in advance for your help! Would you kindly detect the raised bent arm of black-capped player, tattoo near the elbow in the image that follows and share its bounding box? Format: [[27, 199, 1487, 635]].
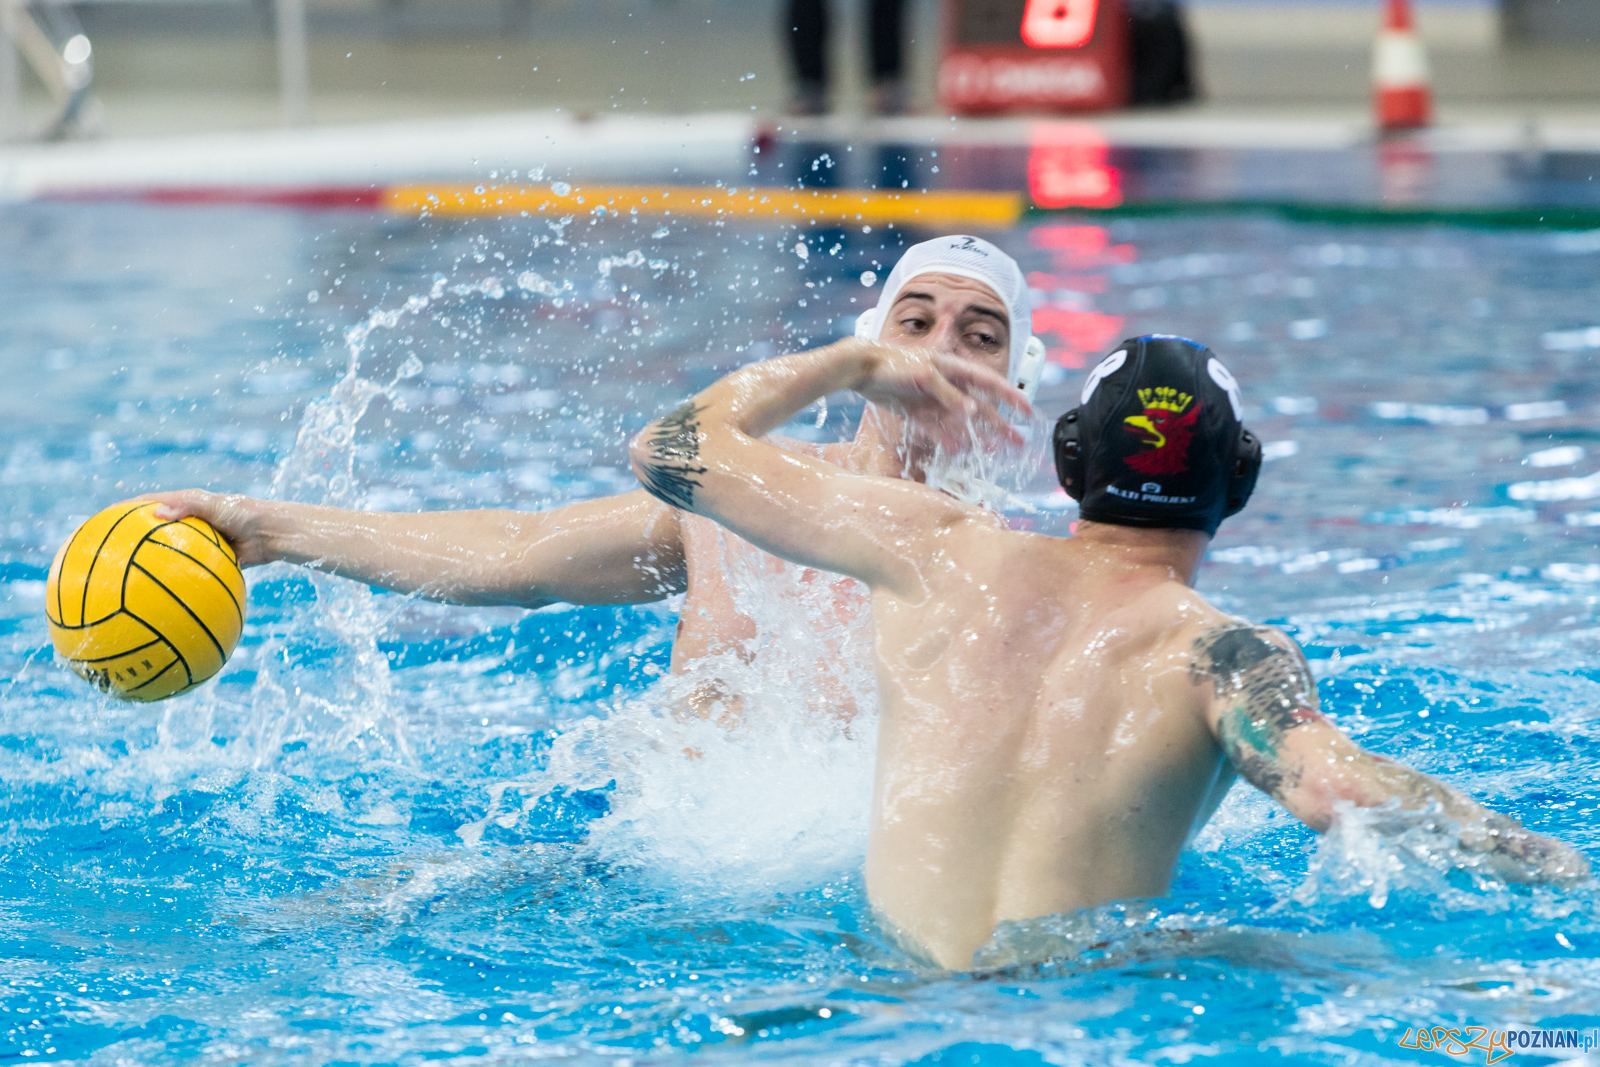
[[630, 339, 1029, 593]]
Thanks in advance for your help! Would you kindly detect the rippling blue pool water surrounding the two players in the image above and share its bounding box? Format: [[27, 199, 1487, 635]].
[[0, 205, 1600, 1065]]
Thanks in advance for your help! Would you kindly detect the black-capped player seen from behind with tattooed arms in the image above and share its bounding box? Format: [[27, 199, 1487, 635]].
[[632, 329, 1589, 969]]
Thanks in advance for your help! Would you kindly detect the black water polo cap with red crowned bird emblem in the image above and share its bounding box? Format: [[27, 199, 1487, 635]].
[[1054, 334, 1261, 534]]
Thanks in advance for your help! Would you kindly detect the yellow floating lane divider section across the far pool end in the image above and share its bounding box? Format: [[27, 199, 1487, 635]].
[[386, 186, 1027, 227]]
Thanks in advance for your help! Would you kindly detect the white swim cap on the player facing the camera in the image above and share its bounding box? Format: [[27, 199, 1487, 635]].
[[856, 234, 1045, 400]]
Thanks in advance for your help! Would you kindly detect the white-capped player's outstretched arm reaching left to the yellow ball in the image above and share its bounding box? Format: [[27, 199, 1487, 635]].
[[142, 490, 685, 608]]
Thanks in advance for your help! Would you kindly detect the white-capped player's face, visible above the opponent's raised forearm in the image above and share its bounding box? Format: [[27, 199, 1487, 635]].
[[878, 274, 1011, 376]]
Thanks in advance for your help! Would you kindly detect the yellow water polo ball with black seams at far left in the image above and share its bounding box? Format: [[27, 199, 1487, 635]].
[[45, 501, 245, 701]]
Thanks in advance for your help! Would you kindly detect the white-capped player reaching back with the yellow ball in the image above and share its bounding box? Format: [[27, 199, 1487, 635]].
[[140, 235, 1043, 721]]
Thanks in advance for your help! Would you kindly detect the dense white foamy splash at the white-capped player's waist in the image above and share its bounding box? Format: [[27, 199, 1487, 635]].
[[458, 653, 877, 894]]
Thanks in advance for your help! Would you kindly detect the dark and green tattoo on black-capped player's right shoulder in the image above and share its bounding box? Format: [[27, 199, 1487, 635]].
[[1189, 622, 1323, 795]]
